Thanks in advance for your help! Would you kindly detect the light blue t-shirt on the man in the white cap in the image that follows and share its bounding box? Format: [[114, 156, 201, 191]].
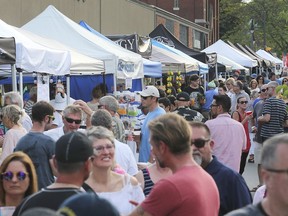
[[139, 107, 166, 162]]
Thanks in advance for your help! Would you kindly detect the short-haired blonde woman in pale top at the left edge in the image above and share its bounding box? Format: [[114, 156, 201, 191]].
[[0, 105, 27, 165]]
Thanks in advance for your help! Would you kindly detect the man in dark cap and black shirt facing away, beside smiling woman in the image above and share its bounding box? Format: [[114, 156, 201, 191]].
[[13, 131, 93, 216]]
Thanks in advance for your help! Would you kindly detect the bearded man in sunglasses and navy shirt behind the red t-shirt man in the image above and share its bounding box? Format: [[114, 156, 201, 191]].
[[189, 122, 252, 215]]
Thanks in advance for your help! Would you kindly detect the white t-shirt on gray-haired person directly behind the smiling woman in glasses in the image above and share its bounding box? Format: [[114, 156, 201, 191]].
[[114, 139, 138, 176]]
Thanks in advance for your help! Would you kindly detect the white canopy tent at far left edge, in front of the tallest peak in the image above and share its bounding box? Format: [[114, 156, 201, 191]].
[[0, 20, 71, 93]]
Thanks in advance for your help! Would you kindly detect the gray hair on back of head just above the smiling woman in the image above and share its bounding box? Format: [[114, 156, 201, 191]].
[[91, 109, 113, 130]]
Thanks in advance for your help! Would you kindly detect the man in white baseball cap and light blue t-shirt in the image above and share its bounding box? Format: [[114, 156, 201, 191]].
[[139, 86, 166, 162]]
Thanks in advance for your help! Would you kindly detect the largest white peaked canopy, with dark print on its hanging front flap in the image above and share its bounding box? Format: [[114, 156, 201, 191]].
[[22, 5, 144, 81]]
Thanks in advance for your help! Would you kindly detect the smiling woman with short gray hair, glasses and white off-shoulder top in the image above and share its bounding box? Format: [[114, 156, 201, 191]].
[[83, 126, 145, 215]]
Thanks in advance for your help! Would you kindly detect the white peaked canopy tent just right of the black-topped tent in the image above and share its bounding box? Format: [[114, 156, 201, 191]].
[[202, 40, 258, 68]]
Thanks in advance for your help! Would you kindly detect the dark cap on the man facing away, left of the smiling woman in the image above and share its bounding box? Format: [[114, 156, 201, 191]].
[[55, 131, 93, 163]]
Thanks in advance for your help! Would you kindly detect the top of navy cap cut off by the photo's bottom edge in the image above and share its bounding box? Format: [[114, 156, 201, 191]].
[[58, 192, 120, 216]]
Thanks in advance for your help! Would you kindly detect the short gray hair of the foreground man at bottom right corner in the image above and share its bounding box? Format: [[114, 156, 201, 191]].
[[261, 134, 288, 168]]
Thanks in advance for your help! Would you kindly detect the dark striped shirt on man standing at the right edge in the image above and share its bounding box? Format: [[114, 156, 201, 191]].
[[261, 97, 287, 138]]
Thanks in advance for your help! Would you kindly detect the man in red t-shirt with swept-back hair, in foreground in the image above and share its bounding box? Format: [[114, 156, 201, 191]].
[[130, 113, 219, 216]]
